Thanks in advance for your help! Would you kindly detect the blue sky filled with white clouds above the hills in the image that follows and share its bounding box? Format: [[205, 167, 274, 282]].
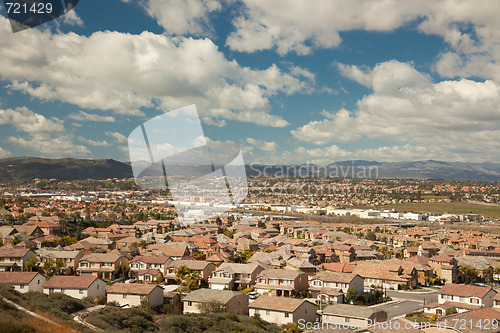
[[0, 0, 500, 165]]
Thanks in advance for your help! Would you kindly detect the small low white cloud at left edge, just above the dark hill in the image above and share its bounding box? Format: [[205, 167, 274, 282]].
[[0, 107, 90, 157]]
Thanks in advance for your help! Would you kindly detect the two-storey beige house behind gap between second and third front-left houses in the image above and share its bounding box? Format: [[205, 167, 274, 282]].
[[78, 252, 128, 280]]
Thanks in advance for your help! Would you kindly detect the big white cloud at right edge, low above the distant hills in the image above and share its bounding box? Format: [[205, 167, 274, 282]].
[[292, 61, 500, 161]]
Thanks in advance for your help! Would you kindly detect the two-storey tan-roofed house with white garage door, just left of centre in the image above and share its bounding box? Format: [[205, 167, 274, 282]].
[[208, 263, 264, 290]]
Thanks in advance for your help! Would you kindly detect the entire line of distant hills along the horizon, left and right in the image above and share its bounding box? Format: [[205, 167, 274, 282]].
[[0, 157, 500, 183]]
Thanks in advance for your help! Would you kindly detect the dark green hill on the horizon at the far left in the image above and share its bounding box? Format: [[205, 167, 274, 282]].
[[0, 157, 133, 183]]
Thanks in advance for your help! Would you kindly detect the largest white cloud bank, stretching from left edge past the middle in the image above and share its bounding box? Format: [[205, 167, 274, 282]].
[[0, 17, 311, 127]]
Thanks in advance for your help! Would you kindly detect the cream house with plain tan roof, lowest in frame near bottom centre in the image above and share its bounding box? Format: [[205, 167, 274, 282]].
[[248, 295, 317, 325]]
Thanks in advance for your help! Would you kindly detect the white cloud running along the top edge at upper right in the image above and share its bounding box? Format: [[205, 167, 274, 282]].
[[227, 0, 500, 61]]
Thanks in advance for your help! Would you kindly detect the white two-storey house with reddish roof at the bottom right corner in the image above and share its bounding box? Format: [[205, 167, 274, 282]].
[[424, 283, 497, 316]]
